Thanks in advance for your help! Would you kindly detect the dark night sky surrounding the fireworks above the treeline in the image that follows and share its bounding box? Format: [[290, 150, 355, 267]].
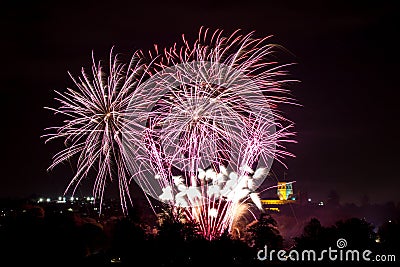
[[0, 0, 400, 205]]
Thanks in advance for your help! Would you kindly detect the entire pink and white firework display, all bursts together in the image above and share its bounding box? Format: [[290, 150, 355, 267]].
[[44, 28, 294, 239]]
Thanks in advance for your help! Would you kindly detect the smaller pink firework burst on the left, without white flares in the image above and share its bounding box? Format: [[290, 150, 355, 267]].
[[44, 50, 143, 215]]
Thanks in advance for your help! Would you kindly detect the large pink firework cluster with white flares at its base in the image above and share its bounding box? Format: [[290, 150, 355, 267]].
[[124, 29, 294, 239]]
